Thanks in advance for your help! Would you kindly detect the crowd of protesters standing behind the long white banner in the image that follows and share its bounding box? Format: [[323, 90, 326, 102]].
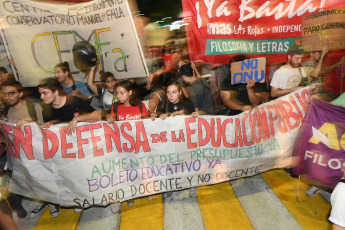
[[0, 36, 345, 228]]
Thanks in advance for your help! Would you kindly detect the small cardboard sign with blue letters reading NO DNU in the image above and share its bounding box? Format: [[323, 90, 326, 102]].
[[231, 58, 266, 85]]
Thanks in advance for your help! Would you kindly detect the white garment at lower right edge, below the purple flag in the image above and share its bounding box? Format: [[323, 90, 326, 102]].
[[328, 179, 345, 228]]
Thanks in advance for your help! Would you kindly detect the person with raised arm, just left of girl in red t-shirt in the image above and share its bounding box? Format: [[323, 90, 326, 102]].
[[87, 66, 117, 118]]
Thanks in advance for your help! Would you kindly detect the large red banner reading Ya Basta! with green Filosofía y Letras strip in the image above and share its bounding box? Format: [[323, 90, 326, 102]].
[[182, 0, 345, 64]]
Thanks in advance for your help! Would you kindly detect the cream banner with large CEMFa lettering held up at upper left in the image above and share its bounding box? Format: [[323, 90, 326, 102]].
[[0, 0, 147, 86]]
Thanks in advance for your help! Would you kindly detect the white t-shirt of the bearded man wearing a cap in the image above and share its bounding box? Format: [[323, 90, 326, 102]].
[[271, 66, 307, 89]]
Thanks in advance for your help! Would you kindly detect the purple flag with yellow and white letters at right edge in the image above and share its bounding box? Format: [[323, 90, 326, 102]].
[[293, 100, 345, 188]]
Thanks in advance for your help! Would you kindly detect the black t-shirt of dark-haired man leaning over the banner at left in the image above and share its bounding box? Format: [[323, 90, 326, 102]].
[[44, 95, 95, 122]]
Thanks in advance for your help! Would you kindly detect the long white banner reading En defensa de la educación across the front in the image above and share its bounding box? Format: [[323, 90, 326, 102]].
[[2, 88, 309, 208]]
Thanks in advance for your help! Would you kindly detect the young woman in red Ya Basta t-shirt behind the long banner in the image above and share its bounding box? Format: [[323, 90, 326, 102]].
[[106, 80, 148, 213]]
